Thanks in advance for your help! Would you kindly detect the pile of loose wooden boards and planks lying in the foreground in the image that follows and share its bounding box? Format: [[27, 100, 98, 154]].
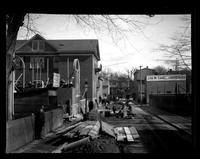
[[52, 121, 139, 153]]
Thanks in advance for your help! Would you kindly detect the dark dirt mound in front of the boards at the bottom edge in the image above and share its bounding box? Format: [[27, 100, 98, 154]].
[[63, 134, 121, 153]]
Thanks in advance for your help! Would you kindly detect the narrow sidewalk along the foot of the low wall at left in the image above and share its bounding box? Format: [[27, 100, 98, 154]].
[[10, 121, 80, 153]]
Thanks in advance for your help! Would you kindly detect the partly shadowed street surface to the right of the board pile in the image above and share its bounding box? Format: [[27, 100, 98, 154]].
[[100, 104, 192, 153]]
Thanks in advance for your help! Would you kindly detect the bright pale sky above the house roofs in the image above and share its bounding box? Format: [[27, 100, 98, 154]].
[[18, 14, 191, 73]]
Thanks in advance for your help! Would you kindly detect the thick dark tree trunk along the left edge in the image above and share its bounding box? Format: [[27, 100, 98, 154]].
[[6, 13, 26, 120]]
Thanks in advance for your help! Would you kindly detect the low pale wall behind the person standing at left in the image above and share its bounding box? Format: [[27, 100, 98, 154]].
[[6, 109, 63, 153]]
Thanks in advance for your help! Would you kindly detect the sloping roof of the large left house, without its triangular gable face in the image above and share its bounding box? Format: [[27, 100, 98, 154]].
[[16, 34, 100, 60]]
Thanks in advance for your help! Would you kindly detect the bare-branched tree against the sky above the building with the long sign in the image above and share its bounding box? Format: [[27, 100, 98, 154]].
[[156, 15, 191, 70]]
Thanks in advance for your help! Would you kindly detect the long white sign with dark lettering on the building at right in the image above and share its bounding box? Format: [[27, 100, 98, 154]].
[[147, 74, 186, 81]]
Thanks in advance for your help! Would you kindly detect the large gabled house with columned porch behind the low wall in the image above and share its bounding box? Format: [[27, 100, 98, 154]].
[[15, 34, 101, 115]]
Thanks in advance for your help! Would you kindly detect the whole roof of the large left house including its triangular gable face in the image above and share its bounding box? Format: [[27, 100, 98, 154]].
[[16, 34, 100, 60]]
